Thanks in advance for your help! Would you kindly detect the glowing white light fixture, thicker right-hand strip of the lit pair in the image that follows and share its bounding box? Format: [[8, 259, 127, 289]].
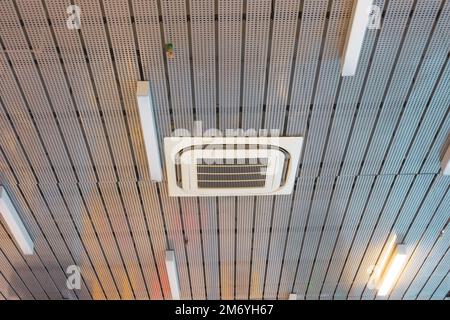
[[377, 245, 407, 297]]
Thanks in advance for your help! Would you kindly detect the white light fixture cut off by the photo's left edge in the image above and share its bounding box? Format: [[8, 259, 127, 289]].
[[0, 186, 34, 255]]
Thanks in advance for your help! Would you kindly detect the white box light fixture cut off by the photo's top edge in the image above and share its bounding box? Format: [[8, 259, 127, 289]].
[[342, 0, 373, 77]]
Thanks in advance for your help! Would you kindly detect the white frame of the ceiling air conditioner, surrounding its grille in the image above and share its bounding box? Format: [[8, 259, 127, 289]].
[[164, 137, 303, 197]]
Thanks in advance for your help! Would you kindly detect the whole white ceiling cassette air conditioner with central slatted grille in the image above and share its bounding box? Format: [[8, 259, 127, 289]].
[[164, 137, 303, 197]]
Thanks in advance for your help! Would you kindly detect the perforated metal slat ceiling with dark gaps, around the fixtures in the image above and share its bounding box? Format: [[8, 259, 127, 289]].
[[0, 0, 450, 300]]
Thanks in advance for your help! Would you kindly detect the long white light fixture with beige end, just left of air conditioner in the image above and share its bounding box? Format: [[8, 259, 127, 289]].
[[137, 81, 162, 181]]
